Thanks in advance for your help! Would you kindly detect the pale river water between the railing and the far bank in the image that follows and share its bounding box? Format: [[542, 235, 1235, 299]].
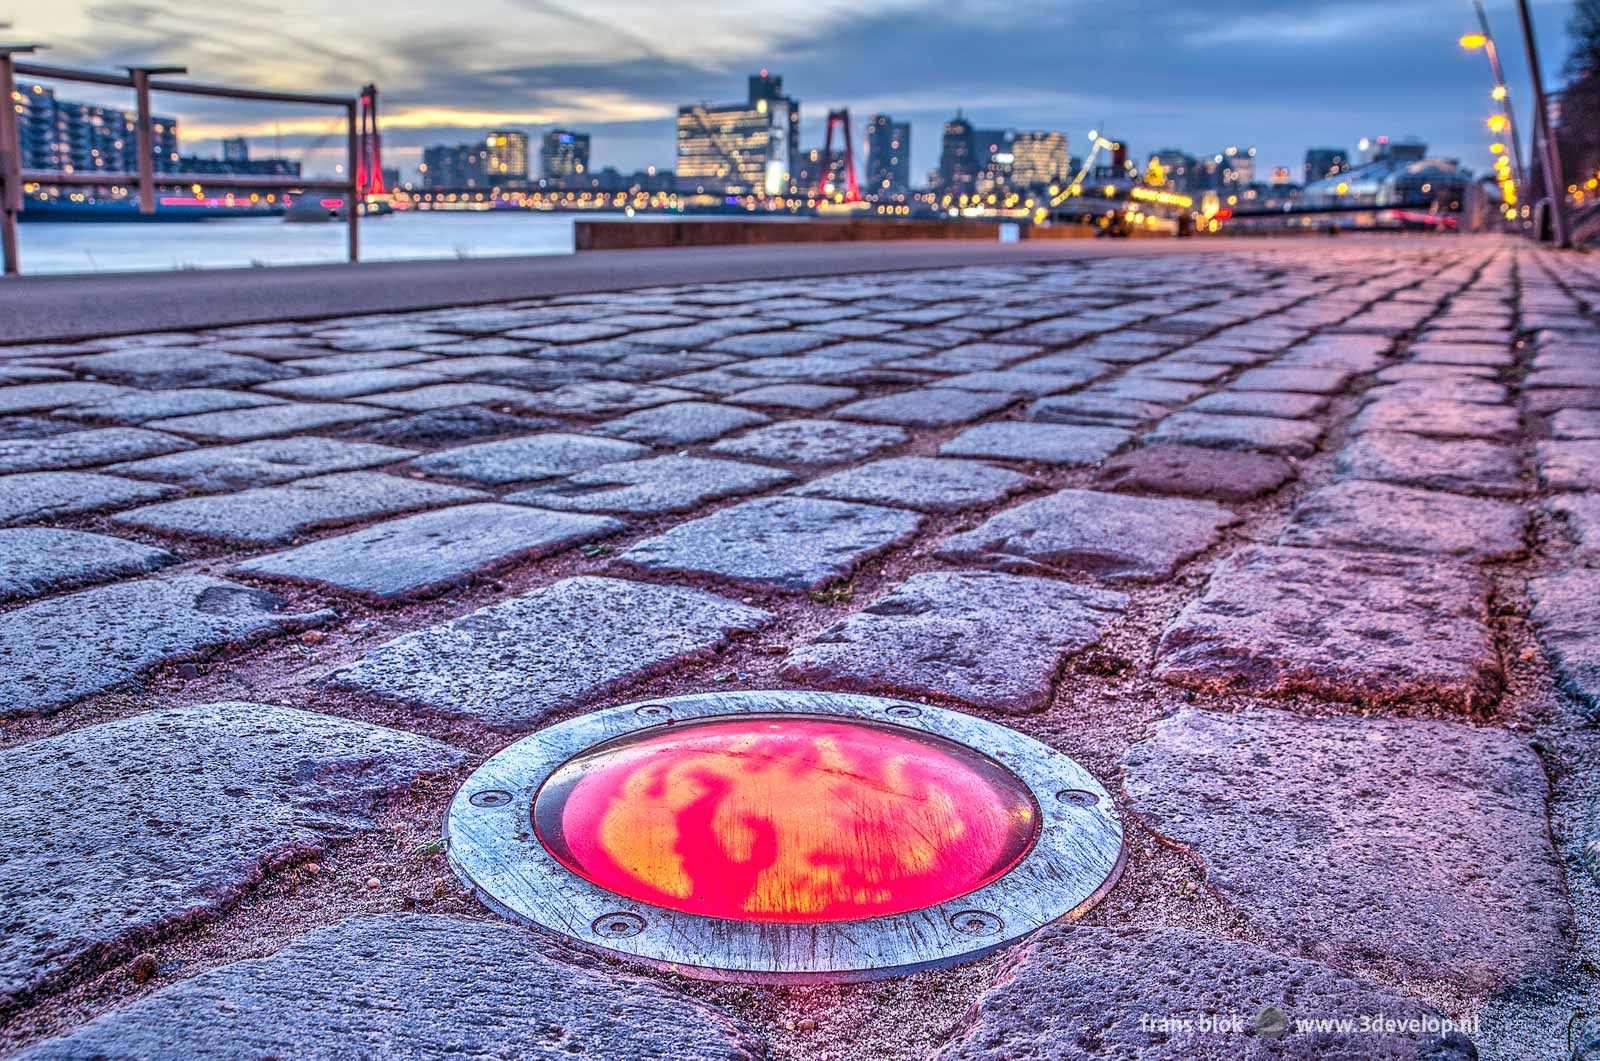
[[19, 210, 595, 275]]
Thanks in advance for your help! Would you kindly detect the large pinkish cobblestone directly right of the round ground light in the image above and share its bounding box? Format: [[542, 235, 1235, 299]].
[[1123, 709, 1571, 994]]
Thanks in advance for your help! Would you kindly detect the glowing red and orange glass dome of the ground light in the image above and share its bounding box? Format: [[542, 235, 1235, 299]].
[[533, 715, 1038, 922]]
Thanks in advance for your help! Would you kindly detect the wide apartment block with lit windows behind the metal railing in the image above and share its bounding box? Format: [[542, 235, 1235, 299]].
[[13, 83, 178, 173]]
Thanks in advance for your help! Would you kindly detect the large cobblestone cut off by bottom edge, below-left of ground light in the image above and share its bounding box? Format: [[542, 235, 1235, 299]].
[[12, 914, 766, 1061]]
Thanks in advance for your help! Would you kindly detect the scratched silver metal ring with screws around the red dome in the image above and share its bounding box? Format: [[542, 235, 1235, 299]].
[[445, 691, 1123, 983]]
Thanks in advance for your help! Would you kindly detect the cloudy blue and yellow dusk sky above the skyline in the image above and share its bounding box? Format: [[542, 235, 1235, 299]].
[[12, 0, 1570, 174]]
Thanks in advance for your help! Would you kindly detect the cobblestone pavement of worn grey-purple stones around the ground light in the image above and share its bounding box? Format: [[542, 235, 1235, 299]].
[[0, 238, 1600, 1061]]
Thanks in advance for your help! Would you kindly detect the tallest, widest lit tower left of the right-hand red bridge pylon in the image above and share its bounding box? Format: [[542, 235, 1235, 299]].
[[677, 70, 800, 195]]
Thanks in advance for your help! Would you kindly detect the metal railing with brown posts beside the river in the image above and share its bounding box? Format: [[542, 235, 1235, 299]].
[[0, 45, 362, 275]]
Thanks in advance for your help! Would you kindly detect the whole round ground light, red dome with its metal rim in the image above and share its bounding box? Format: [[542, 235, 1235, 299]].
[[446, 691, 1123, 983]]
